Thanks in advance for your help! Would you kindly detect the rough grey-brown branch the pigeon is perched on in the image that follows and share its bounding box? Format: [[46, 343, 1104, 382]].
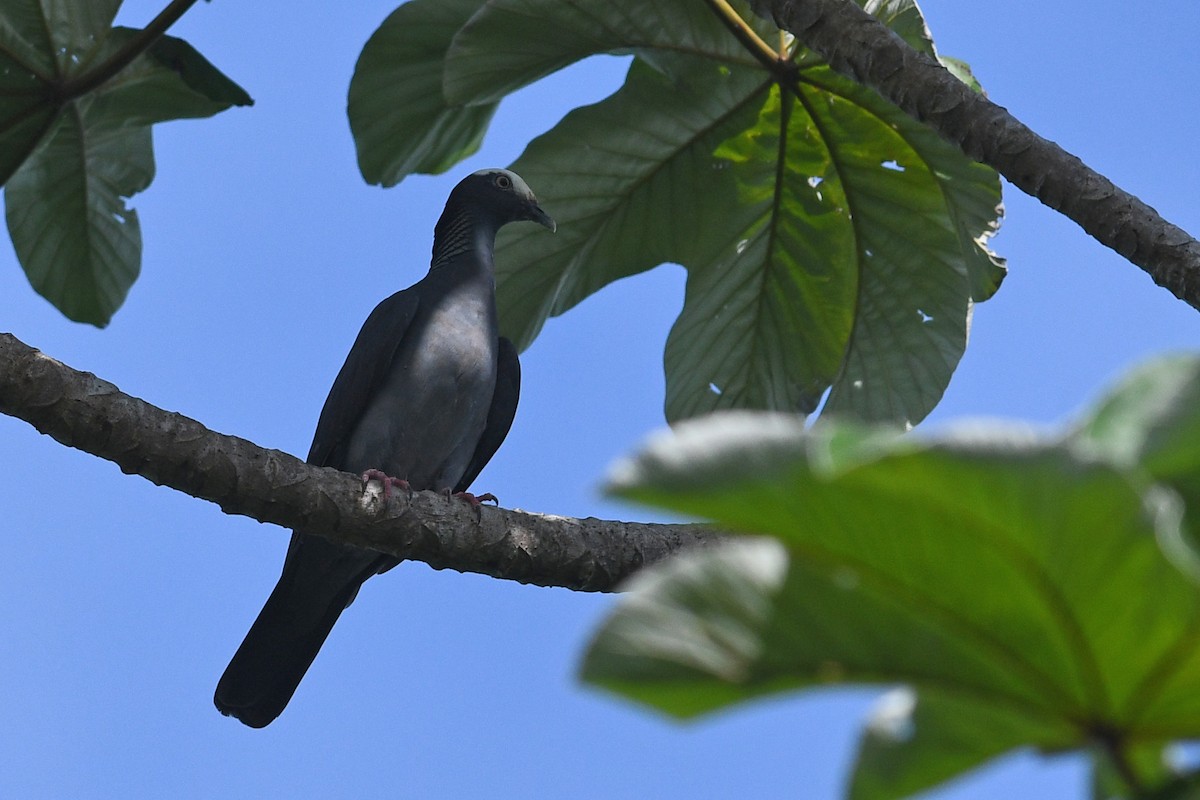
[[0, 333, 716, 591]]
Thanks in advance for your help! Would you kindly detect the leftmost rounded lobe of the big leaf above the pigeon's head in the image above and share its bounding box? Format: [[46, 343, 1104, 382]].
[[348, 0, 496, 186]]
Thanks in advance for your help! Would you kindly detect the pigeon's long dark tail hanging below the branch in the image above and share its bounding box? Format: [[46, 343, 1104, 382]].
[[212, 534, 394, 728]]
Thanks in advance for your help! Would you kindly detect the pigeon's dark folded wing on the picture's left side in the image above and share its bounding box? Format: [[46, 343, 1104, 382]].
[[308, 285, 420, 468]]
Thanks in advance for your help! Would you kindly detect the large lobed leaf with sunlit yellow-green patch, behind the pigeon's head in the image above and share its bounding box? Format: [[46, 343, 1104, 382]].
[[350, 0, 1003, 423]]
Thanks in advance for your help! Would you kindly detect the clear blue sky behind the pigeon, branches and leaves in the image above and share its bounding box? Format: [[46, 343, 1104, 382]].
[[0, 0, 1200, 800]]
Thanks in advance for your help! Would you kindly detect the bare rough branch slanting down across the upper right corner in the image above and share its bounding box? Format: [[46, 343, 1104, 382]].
[[750, 0, 1200, 308]]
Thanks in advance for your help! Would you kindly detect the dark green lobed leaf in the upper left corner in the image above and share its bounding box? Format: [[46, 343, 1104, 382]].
[[0, 0, 252, 326]]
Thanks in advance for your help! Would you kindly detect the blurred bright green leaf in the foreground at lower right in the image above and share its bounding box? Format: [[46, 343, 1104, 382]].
[[583, 413, 1200, 799]]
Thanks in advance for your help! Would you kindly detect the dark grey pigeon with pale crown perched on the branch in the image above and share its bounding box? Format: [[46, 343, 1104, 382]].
[[214, 169, 554, 728]]
